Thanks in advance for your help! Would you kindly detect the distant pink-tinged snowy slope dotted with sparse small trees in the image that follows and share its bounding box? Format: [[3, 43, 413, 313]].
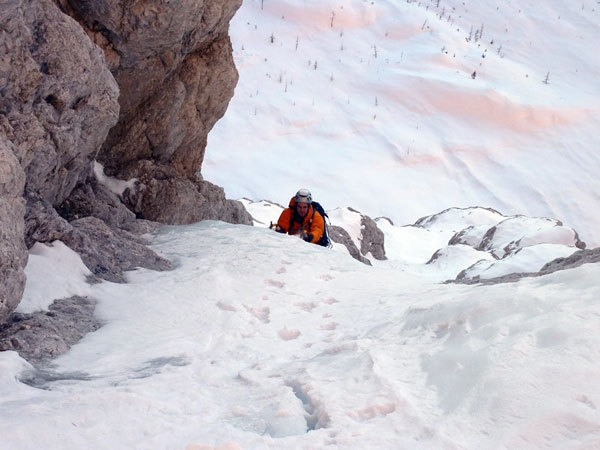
[[202, 0, 600, 248]]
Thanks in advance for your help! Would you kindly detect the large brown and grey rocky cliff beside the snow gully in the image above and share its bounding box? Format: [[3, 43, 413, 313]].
[[0, 0, 251, 324]]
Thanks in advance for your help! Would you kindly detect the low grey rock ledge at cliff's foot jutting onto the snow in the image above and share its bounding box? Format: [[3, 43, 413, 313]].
[[62, 217, 171, 283]]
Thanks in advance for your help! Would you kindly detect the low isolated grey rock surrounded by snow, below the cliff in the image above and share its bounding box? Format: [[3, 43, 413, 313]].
[[0, 296, 100, 363]]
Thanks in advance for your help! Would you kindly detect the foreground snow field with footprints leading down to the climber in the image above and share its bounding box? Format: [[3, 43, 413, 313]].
[[0, 222, 600, 450]]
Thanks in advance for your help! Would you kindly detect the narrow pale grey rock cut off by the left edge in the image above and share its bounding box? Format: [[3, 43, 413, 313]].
[[0, 135, 27, 323]]
